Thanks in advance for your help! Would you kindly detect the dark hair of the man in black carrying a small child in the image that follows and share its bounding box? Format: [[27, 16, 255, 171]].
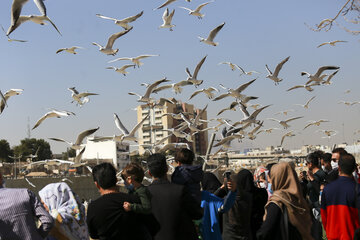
[[92, 163, 117, 189]]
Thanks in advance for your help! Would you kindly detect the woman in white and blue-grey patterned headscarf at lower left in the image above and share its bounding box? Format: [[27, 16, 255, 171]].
[[39, 182, 89, 240]]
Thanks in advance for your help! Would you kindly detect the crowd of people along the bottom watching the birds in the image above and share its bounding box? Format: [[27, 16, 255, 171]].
[[0, 148, 360, 240]]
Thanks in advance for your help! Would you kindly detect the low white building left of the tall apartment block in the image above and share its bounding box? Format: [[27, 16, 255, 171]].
[[82, 137, 130, 170]]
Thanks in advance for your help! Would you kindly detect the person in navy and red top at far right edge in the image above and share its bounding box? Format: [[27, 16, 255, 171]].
[[321, 153, 360, 240]]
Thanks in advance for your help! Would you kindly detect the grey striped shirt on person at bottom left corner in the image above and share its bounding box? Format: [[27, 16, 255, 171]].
[[0, 188, 54, 240]]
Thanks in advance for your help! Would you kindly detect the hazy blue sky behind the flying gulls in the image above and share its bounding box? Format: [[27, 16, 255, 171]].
[[0, 0, 360, 153]]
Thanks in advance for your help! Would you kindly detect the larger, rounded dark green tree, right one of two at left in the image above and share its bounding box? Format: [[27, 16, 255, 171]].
[[13, 138, 52, 161]]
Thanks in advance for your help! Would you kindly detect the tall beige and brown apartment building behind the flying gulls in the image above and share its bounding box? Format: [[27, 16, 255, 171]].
[[137, 102, 208, 155]]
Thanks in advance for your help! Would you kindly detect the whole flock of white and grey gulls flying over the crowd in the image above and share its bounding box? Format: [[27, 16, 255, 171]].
[[0, 0, 360, 164]]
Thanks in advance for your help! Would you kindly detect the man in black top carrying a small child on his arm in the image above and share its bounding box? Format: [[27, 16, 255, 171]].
[[87, 163, 144, 240]]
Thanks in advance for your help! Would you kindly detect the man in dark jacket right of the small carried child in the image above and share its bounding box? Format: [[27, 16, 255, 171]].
[[147, 154, 203, 240]]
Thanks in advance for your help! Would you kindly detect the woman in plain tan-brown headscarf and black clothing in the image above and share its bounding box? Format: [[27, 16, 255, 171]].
[[257, 162, 313, 240]]
